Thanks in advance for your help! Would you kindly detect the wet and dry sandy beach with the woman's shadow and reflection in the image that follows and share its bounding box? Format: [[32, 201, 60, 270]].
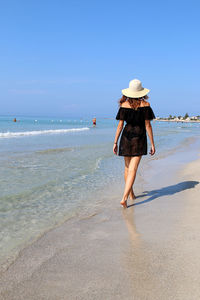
[[0, 139, 200, 300]]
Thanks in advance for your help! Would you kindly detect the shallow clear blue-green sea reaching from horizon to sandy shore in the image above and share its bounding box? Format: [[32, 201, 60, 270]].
[[0, 116, 200, 271]]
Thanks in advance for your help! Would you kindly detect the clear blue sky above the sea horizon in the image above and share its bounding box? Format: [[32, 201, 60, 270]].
[[0, 0, 200, 117]]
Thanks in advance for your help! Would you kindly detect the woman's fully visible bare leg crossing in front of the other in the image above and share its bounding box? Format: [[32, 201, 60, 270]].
[[120, 156, 141, 207]]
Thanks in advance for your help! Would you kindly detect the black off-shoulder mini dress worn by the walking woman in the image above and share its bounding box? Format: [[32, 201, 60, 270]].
[[116, 106, 155, 156]]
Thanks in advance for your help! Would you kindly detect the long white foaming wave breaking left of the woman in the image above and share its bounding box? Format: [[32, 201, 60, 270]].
[[0, 127, 90, 138]]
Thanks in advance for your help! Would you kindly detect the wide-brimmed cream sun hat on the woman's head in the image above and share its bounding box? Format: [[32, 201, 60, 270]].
[[122, 79, 150, 98]]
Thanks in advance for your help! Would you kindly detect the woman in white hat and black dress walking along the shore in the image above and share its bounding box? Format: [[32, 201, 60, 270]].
[[113, 79, 155, 208]]
